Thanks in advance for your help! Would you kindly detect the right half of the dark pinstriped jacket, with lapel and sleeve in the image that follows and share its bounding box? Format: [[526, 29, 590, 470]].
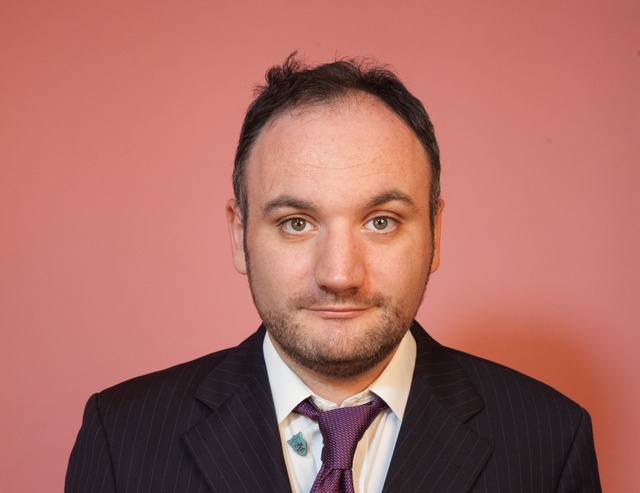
[[384, 324, 601, 493]]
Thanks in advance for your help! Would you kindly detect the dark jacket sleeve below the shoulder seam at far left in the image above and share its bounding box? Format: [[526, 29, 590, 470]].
[[64, 394, 116, 493]]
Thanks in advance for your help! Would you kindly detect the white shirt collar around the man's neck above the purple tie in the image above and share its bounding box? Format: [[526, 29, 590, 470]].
[[263, 331, 416, 423]]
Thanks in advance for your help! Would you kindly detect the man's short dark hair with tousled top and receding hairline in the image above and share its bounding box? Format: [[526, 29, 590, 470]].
[[233, 53, 440, 226]]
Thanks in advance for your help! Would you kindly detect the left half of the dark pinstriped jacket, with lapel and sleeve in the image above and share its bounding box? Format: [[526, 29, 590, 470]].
[[65, 330, 290, 493]]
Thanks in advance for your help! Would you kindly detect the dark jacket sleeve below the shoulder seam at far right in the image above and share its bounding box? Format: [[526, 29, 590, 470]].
[[557, 409, 602, 493]]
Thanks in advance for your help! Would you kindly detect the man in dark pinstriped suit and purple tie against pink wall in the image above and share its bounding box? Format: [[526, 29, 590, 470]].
[[66, 57, 600, 493]]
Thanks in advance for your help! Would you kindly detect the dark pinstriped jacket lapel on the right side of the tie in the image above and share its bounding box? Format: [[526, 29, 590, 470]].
[[384, 323, 493, 493]]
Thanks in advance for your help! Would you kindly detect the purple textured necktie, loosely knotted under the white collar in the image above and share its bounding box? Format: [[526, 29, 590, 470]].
[[293, 396, 389, 493]]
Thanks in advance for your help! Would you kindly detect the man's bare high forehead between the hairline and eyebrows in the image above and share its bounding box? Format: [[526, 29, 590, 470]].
[[246, 94, 429, 208]]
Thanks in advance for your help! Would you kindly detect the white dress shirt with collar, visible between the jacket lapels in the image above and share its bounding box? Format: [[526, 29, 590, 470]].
[[263, 332, 416, 493]]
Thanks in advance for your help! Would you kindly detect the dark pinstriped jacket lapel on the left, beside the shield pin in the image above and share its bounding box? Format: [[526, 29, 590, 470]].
[[184, 327, 291, 493]]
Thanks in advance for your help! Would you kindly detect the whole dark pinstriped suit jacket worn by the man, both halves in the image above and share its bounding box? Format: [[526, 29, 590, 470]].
[[65, 324, 600, 493]]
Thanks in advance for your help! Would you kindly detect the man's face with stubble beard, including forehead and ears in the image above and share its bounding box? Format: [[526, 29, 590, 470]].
[[227, 95, 440, 378]]
